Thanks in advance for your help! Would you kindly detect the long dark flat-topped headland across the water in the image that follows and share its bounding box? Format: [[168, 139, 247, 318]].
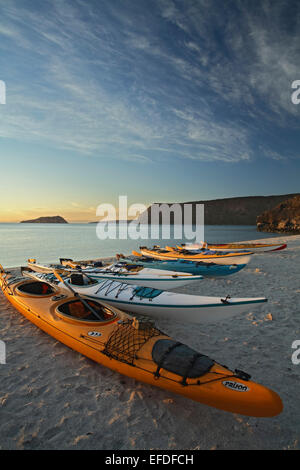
[[139, 194, 295, 225]]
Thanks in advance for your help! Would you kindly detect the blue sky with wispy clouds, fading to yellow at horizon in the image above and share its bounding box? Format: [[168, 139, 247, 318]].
[[0, 0, 300, 222]]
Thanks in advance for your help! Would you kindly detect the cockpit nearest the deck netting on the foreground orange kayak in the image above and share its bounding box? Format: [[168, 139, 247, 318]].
[[55, 299, 117, 323]]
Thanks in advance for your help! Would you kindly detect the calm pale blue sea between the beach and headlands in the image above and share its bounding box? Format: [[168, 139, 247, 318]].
[[0, 223, 284, 267]]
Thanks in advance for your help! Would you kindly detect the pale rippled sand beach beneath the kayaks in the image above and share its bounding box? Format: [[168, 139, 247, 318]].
[[0, 235, 300, 450]]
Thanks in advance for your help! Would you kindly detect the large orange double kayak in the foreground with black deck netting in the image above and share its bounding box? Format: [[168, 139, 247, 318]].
[[0, 270, 283, 417]]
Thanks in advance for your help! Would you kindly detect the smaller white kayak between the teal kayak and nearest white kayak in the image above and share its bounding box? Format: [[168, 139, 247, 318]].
[[27, 259, 203, 290]]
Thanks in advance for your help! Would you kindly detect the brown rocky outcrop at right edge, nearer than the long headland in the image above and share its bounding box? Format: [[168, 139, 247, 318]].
[[257, 196, 300, 233]]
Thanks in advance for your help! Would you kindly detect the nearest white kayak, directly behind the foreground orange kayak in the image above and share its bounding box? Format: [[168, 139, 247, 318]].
[[24, 271, 267, 323]]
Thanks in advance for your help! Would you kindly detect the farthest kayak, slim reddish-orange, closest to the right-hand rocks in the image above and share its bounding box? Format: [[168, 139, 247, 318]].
[[177, 242, 287, 253]]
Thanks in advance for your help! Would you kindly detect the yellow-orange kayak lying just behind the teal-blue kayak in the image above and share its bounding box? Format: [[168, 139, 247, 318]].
[[140, 246, 252, 265]]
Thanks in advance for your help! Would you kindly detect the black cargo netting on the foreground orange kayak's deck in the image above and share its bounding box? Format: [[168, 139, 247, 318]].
[[102, 318, 163, 365]]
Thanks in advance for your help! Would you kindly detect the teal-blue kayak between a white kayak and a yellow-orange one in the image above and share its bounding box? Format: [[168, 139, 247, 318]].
[[119, 251, 246, 277]]
